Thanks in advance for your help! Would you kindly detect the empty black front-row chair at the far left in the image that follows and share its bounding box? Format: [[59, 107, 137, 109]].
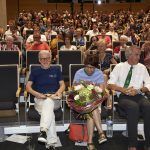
[[0, 64, 21, 125]]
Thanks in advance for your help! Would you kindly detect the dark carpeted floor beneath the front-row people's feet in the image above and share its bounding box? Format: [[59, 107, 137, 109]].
[[0, 132, 144, 150]]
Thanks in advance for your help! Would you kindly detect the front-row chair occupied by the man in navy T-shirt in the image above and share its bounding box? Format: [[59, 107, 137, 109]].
[[24, 64, 65, 125]]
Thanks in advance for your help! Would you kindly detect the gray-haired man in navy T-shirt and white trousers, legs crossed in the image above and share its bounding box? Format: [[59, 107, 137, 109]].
[[26, 50, 65, 150]]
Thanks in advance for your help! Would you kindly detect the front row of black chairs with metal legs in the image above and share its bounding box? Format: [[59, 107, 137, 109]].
[[0, 64, 110, 125]]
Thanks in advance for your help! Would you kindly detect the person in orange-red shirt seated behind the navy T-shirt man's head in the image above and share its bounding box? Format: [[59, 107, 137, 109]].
[[26, 31, 50, 50]]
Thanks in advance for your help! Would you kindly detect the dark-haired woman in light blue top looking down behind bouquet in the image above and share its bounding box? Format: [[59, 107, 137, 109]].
[[73, 57, 107, 150]]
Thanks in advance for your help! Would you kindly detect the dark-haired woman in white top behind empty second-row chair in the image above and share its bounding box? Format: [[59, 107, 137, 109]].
[[60, 34, 77, 50]]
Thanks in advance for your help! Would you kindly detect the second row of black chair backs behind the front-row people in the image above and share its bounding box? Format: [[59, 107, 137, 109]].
[[0, 49, 144, 66]]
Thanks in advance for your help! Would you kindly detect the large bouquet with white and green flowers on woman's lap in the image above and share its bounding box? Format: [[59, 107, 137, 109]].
[[68, 81, 107, 114]]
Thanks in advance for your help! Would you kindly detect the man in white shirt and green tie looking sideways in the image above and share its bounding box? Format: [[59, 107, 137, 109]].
[[108, 46, 150, 150]]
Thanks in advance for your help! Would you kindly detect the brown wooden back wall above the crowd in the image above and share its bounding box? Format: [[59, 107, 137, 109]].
[[6, 0, 150, 20]]
